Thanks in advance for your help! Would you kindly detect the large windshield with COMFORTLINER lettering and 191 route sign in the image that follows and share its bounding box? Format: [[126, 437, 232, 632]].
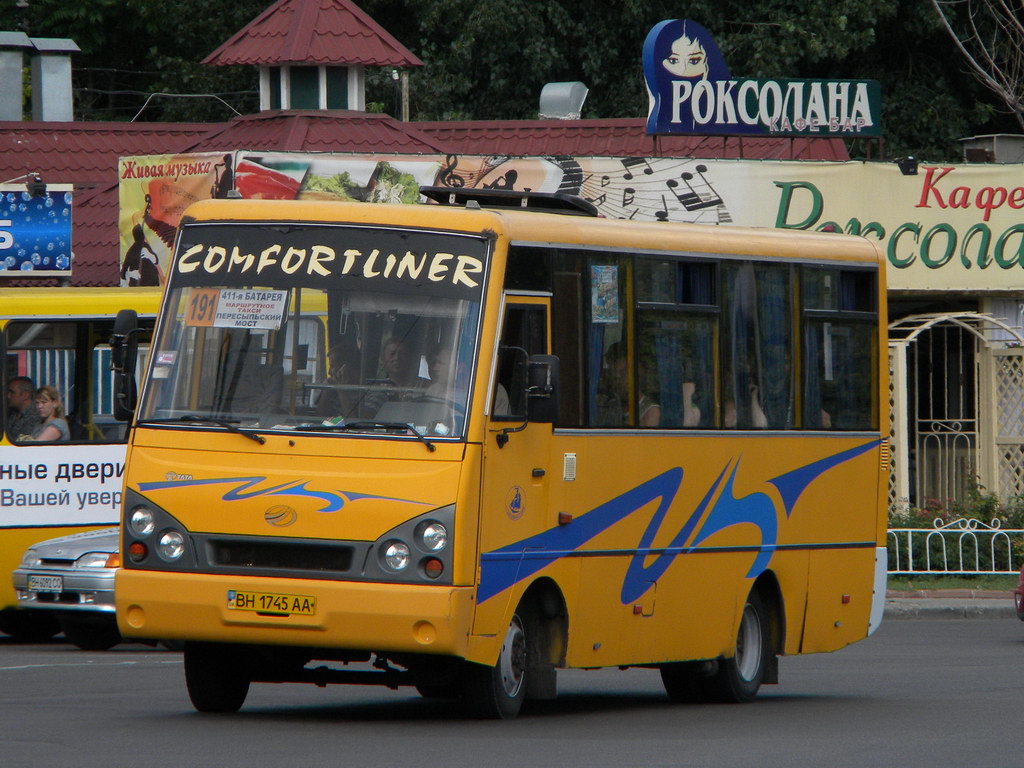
[[138, 223, 487, 438]]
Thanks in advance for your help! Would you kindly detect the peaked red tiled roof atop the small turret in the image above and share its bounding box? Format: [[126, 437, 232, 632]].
[[203, 0, 423, 67]]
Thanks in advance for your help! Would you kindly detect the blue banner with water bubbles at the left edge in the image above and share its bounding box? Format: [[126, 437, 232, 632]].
[[0, 184, 72, 276]]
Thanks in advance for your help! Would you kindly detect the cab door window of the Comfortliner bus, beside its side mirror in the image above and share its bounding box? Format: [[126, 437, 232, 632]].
[[490, 304, 548, 419]]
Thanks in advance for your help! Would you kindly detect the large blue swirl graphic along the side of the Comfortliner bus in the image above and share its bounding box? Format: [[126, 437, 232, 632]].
[[477, 440, 881, 604]]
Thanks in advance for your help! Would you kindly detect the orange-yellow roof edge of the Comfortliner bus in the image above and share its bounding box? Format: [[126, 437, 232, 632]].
[[182, 200, 883, 263]]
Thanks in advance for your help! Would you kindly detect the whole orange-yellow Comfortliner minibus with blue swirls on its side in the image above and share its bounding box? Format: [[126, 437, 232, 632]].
[[116, 188, 888, 717]]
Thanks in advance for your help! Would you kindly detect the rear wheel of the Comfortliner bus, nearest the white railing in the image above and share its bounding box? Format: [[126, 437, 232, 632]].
[[706, 591, 773, 703]]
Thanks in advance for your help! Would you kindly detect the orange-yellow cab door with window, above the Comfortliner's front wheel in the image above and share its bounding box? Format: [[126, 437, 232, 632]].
[[473, 293, 557, 635]]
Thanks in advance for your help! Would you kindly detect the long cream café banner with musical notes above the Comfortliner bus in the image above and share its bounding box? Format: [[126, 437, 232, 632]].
[[121, 152, 1024, 292]]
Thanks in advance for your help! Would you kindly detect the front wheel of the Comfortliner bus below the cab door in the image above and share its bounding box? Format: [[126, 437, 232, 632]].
[[463, 611, 534, 720]]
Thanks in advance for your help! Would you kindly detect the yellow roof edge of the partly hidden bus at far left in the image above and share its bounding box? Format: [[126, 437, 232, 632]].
[[0, 287, 163, 319]]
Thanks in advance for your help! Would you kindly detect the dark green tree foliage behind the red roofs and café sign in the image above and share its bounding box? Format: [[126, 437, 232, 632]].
[[0, 0, 1019, 160]]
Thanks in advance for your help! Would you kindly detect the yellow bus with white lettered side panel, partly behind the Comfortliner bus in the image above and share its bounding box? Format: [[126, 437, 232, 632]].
[[0, 288, 161, 640]]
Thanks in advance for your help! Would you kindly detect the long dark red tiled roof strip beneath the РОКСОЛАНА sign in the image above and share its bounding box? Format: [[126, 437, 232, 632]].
[[412, 118, 850, 161]]
